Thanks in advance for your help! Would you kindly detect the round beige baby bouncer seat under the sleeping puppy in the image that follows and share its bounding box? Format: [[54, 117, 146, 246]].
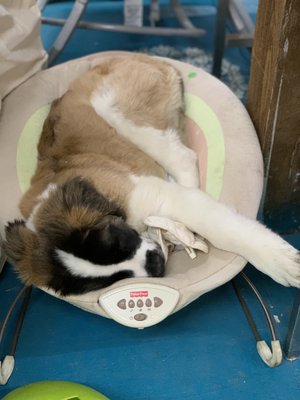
[[0, 52, 263, 328]]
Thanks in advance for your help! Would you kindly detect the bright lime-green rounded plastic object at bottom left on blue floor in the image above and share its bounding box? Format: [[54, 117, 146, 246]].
[[2, 381, 109, 400]]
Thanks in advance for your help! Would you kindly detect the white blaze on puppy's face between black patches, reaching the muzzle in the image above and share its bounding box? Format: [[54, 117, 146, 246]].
[[56, 239, 156, 278]]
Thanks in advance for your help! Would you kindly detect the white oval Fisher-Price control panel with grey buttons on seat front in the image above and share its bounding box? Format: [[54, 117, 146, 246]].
[[99, 283, 179, 328]]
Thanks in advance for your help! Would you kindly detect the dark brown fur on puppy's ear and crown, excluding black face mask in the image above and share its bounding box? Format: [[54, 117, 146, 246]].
[[4, 178, 125, 287]]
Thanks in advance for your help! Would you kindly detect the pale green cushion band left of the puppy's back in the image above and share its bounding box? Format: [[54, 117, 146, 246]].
[[17, 104, 51, 193]]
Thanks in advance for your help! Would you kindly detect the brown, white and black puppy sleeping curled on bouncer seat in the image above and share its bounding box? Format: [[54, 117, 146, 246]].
[[5, 55, 300, 295]]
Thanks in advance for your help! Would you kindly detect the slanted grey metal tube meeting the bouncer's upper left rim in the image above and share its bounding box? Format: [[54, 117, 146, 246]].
[[48, 0, 88, 65]]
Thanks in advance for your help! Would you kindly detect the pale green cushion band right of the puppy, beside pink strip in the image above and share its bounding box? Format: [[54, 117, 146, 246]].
[[185, 93, 225, 199]]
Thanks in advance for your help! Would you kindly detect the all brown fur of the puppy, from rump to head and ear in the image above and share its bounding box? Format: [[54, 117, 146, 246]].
[[5, 55, 183, 292]]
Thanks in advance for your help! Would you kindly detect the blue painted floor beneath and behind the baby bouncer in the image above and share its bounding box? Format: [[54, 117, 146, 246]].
[[0, 1, 300, 400]]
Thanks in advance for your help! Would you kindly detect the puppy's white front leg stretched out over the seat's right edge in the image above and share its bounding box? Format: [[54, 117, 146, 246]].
[[128, 177, 300, 287]]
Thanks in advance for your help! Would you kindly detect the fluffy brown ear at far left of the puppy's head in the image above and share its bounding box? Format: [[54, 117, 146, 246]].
[[3, 220, 44, 285]]
